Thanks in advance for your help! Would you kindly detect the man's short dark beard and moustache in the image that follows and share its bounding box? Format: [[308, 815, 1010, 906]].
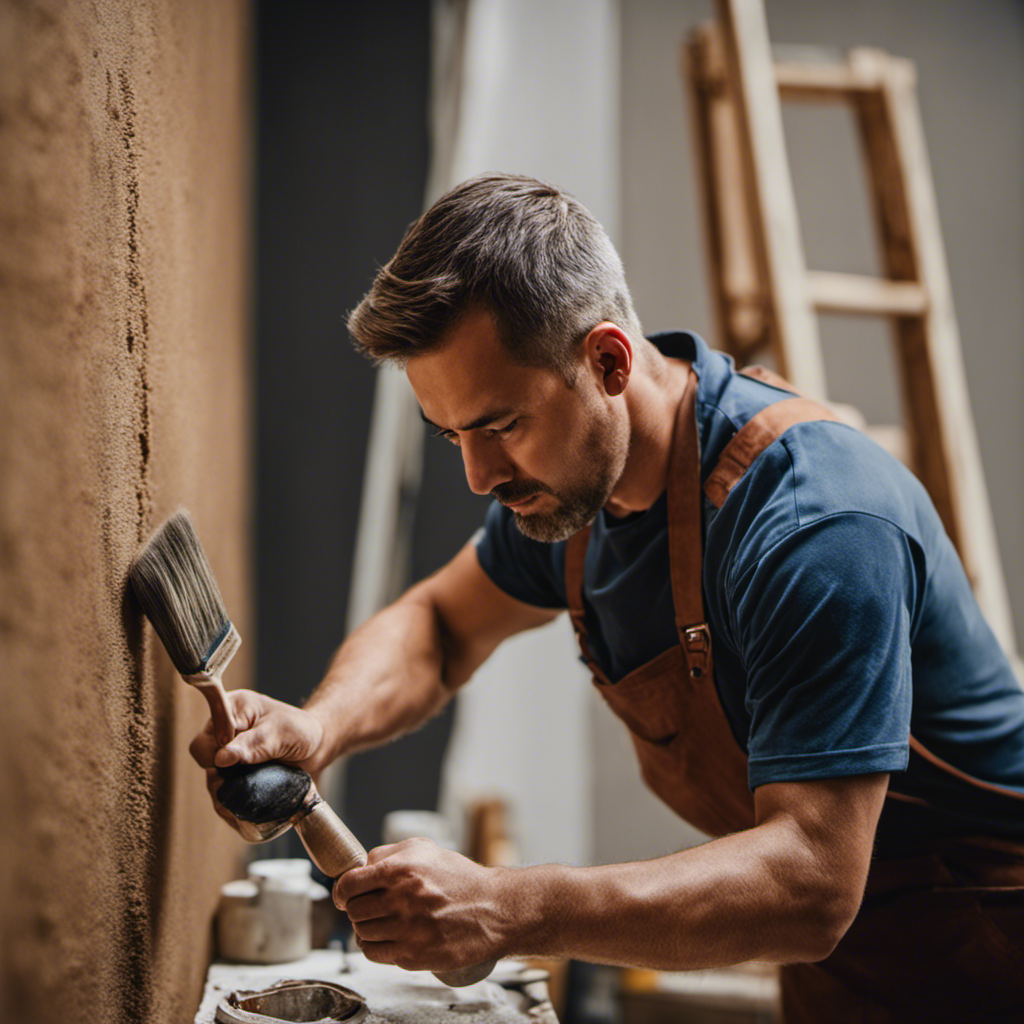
[[490, 405, 629, 544]]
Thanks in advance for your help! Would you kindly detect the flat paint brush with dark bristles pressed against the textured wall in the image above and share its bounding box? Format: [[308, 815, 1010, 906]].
[[128, 509, 242, 746]]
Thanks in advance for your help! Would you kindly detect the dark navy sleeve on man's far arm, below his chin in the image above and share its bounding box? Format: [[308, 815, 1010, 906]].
[[476, 502, 566, 608]]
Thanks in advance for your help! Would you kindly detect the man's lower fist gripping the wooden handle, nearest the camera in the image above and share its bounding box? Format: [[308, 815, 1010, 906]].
[[334, 839, 511, 971]]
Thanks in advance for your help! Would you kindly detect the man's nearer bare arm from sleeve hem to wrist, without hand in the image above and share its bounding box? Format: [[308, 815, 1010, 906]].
[[499, 774, 889, 970]]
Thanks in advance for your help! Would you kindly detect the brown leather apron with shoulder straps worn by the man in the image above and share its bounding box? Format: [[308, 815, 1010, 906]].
[[565, 368, 1024, 1024]]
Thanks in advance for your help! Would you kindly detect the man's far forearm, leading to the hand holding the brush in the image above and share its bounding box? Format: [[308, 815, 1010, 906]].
[[305, 596, 452, 767]]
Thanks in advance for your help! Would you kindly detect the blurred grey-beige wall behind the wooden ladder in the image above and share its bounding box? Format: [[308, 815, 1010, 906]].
[[593, 0, 1024, 860]]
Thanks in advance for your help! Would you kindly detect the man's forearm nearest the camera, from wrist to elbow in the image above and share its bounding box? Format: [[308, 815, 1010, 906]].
[[499, 821, 859, 971]]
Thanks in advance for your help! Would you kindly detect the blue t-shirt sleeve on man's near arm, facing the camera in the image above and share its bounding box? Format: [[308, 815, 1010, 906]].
[[729, 513, 915, 790]]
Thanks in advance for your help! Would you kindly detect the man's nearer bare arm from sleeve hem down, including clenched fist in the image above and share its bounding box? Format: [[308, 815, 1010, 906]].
[[335, 774, 888, 970]]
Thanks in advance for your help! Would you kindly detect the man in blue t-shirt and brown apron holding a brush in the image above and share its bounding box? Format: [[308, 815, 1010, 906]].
[[193, 175, 1024, 1021]]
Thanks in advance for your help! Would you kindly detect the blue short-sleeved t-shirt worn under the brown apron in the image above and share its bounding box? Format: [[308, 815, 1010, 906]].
[[477, 333, 1024, 837]]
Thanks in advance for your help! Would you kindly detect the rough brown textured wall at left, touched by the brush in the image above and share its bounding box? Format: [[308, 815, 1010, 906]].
[[0, 0, 252, 1024]]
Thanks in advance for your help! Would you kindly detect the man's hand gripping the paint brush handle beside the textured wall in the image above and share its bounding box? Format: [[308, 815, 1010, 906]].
[[188, 690, 324, 830]]
